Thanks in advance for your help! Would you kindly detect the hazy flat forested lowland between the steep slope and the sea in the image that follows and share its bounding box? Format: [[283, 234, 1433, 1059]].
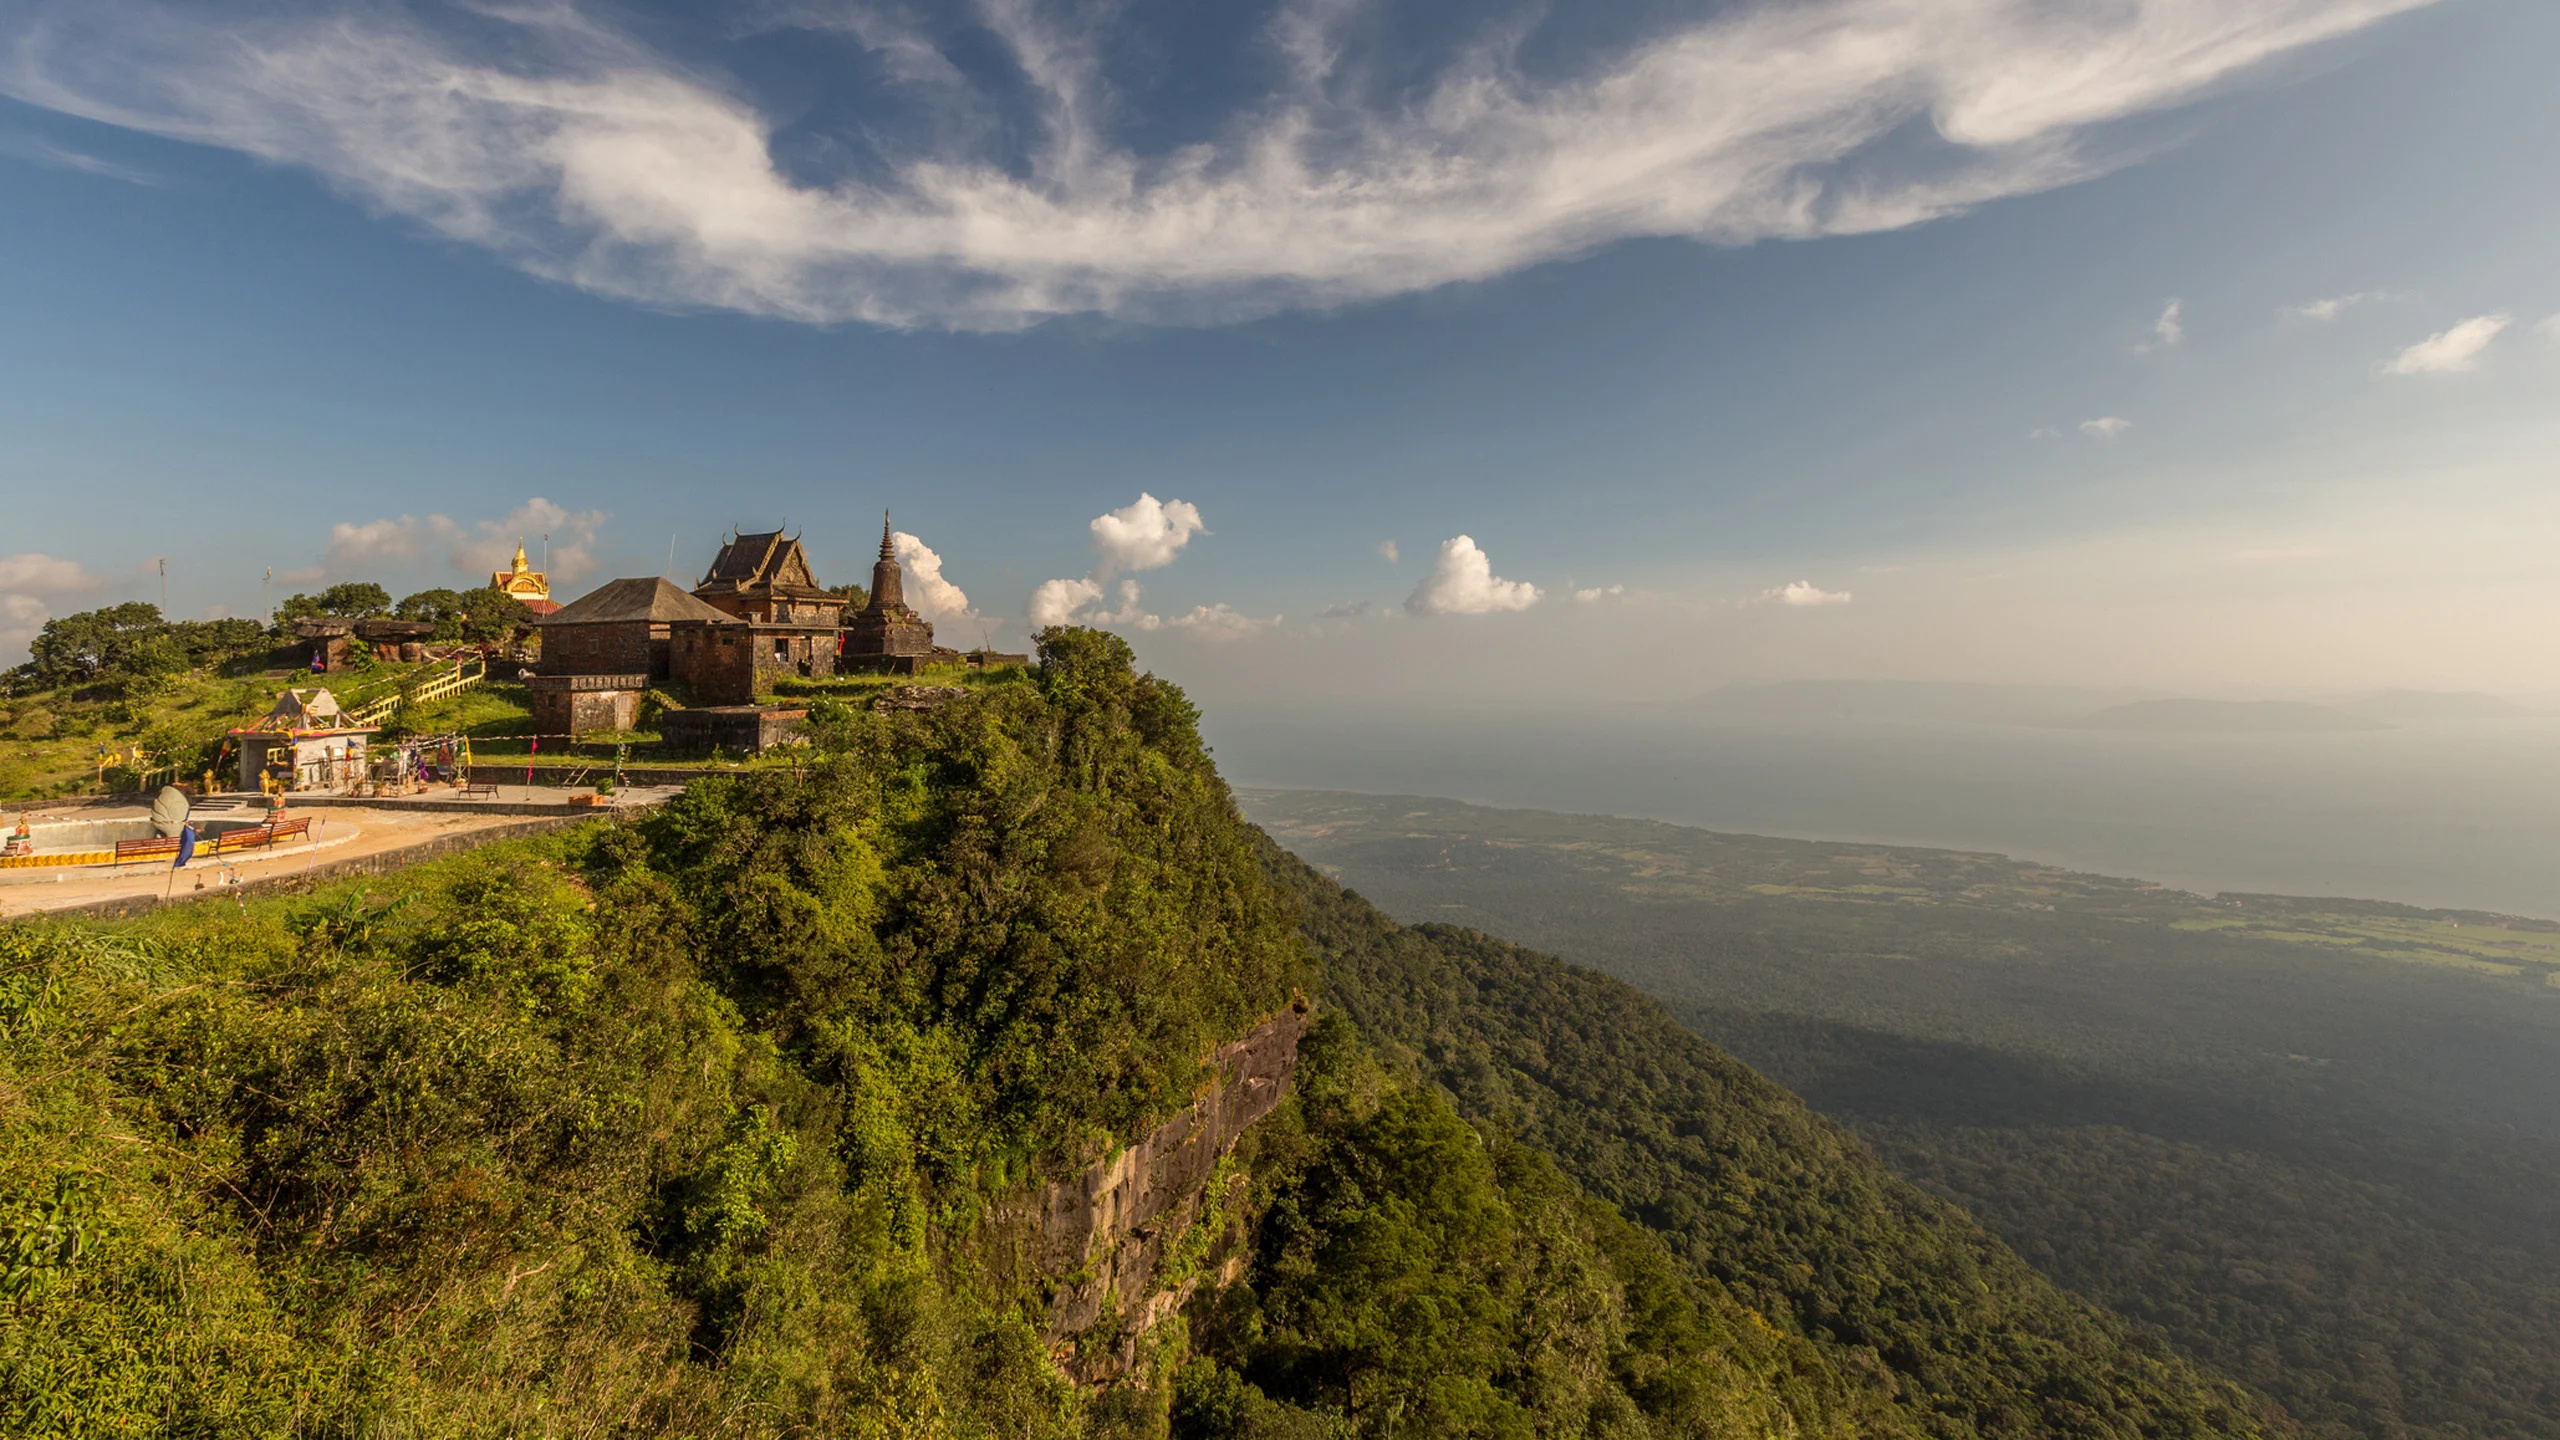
[[1247, 792, 2560, 1440]]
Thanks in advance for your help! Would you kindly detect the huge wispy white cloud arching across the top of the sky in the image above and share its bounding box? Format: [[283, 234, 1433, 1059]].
[[0, 0, 2435, 328]]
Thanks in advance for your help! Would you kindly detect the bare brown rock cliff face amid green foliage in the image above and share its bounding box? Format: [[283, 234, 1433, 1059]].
[[1006, 1004, 1308, 1381]]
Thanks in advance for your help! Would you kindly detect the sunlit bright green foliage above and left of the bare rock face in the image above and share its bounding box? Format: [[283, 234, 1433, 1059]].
[[0, 632, 1306, 1437]]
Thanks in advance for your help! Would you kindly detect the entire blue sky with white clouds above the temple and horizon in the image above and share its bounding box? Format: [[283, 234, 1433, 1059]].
[[0, 0, 2560, 697]]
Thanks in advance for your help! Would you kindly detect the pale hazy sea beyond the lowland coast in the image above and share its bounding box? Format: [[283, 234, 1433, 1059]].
[[1206, 682, 2560, 917]]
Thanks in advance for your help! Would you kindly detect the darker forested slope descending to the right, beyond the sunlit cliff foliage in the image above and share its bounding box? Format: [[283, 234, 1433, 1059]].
[[1272, 851, 2268, 1437]]
